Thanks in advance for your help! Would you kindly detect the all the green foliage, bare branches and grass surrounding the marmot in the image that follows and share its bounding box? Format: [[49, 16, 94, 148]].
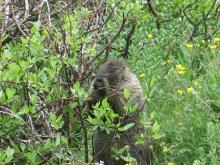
[[0, 0, 220, 165]]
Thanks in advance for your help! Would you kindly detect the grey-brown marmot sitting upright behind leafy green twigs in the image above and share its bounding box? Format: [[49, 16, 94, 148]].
[[87, 59, 151, 165]]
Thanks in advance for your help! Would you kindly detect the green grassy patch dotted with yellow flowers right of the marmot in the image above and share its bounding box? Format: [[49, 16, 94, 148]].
[[125, 22, 220, 165]]
